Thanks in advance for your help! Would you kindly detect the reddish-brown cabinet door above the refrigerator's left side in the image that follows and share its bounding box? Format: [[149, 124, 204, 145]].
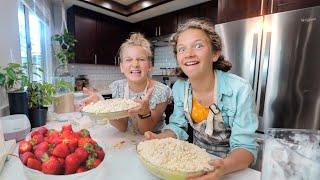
[[218, 0, 261, 23]]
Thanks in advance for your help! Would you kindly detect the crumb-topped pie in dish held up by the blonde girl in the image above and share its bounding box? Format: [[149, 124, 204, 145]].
[[82, 98, 140, 124]]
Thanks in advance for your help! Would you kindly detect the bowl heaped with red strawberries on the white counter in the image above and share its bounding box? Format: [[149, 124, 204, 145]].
[[18, 124, 106, 180]]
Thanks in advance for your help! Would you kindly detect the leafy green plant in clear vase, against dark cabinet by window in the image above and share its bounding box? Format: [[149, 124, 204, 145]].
[[51, 29, 77, 76]]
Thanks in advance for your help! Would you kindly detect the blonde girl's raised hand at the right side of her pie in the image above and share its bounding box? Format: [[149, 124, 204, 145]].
[[128, 87, 153, 115]]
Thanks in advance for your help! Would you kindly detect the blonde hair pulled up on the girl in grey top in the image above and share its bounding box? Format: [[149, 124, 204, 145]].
[[119, 33, 152, 61]]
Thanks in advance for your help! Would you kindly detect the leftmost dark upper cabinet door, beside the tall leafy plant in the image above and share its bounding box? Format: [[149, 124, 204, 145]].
[[74, 15, 97, 64]]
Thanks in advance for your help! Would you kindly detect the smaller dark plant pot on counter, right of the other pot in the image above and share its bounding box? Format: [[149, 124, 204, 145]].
[[29, 107, 48, 128]]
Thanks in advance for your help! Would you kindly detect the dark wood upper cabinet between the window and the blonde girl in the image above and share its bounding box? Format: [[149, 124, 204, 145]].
[[67, 6, 130, 65]]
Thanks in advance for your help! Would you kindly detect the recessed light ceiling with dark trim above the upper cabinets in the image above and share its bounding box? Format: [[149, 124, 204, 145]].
[[64, 0, 210, 23]]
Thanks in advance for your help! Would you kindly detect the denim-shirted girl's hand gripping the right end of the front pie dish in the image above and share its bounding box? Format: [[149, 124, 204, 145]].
[[188, 159, 226, 180]]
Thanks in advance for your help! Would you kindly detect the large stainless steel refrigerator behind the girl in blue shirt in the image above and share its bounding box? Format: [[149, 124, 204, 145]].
[[215, 6, 320, 132]]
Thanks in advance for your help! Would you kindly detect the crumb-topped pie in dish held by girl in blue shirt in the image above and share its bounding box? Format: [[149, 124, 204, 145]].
[[137, 138, 214, 179]]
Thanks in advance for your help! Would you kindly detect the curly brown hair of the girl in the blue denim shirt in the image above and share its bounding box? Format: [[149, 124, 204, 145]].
[[170, 18, 232, 78]]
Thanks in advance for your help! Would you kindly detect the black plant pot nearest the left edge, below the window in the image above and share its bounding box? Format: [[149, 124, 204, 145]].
[[8, 92, 28, 116]]
